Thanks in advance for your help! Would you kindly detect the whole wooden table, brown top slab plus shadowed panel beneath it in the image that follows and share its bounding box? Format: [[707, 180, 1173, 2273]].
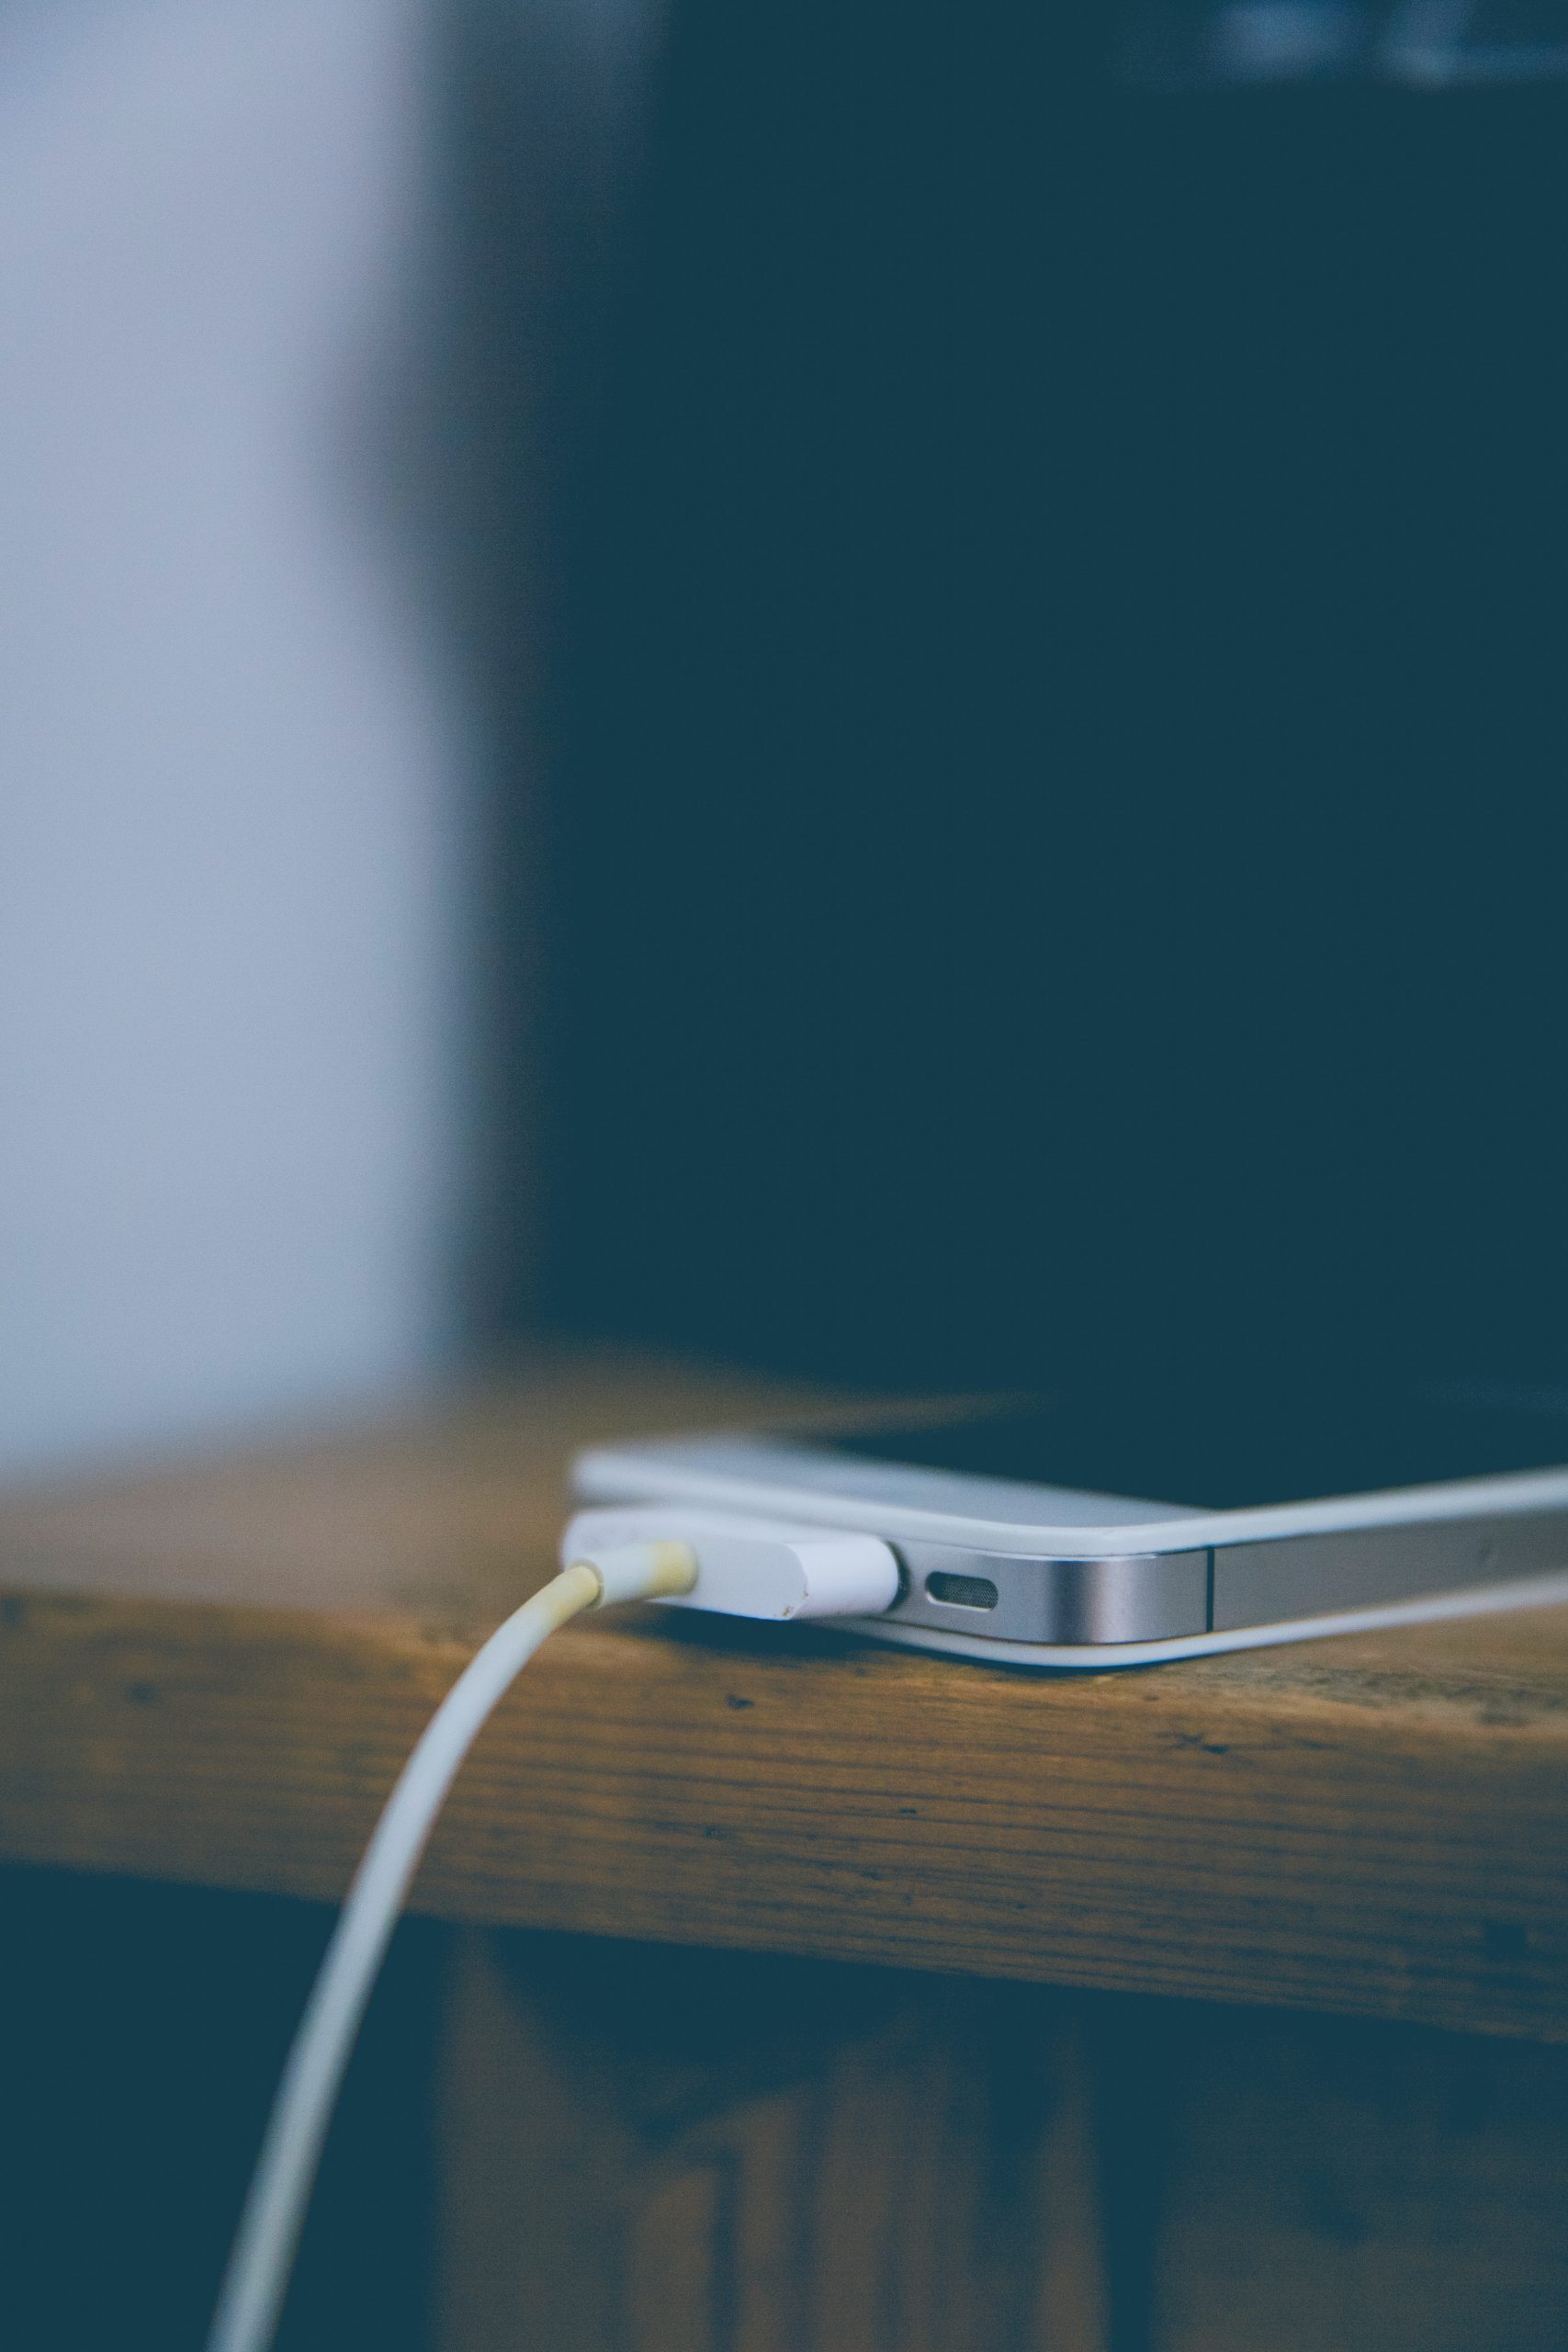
[[0, 1357, 1568, 2352]]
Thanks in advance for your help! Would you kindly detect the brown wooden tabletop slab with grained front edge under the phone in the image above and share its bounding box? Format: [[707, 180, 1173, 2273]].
[[0, 1362, 1568, 2040]]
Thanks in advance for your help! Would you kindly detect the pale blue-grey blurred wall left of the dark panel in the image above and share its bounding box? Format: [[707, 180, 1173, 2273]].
[[0, 0, 466, 1475]]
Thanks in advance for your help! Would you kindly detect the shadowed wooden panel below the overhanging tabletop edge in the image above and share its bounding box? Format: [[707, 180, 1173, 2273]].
[[437, 1933, 1568, 2352]]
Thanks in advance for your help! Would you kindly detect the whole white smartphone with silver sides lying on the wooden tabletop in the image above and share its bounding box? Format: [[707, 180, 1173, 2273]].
[[569, 1387, 1568, 1668]]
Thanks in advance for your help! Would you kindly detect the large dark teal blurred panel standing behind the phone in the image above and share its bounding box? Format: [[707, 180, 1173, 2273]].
[[526, 0, 1568, 1385]]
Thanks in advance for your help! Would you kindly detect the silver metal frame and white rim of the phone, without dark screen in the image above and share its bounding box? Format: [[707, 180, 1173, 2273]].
[[573, 1432, 1568, 1668]]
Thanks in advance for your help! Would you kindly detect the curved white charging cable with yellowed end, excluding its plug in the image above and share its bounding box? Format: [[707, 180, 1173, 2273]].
[[207, 1543, 696, 2352]]
